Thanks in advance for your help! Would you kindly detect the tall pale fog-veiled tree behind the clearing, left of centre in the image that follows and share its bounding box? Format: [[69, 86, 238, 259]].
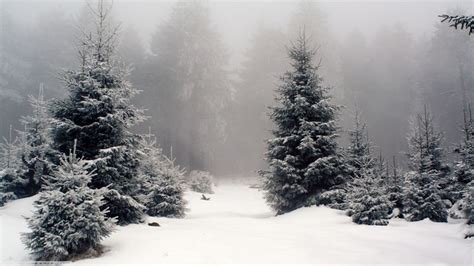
[[146, 1, 231, 170]]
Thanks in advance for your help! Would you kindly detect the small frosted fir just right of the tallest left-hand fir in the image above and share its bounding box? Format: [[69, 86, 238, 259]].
[[141, 129, 186, 218]]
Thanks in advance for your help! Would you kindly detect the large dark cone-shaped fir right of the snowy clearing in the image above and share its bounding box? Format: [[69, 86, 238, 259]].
[[262, 33, 345, 214]]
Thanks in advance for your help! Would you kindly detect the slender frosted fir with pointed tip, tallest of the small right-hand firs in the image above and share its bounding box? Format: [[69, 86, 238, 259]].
[[403, 106, 447, 222]]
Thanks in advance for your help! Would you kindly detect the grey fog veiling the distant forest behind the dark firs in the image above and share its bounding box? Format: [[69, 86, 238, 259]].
[[0, 0, 474, 175]]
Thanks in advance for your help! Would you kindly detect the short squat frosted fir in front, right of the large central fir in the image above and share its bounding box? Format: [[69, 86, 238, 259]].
[[349, 157, 392, 225]]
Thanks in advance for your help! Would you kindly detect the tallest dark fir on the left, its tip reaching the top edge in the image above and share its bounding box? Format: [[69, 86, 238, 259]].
[[52, 0, 144, 223]]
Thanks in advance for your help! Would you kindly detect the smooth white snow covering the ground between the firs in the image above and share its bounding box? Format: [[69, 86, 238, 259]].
[[0, 184, 473, 265]]
